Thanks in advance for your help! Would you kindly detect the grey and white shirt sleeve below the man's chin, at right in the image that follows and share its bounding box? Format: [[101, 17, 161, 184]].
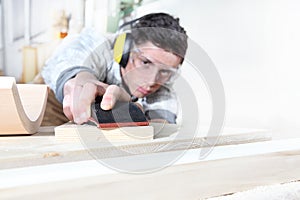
[[140, 86, 178, 124]]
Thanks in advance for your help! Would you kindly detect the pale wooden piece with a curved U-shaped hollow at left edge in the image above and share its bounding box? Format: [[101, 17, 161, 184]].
[[0, 77, 48, 135]]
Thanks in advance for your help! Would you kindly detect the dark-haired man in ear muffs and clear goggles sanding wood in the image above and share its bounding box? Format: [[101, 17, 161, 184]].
[[42, 13, 187, 124]]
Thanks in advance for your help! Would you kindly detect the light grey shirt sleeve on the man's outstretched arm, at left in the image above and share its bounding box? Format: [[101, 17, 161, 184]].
[[42, 28, 113, 102]]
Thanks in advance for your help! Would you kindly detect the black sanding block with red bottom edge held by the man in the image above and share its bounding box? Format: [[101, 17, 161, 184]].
[[89, 96, 149, 128]]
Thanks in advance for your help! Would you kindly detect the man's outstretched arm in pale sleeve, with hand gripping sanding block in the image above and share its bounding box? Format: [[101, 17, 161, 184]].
[[42, 29, 130, 124]]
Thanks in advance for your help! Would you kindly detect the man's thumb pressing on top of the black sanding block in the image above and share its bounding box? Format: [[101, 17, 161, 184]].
[[101, 85, 130, 110]]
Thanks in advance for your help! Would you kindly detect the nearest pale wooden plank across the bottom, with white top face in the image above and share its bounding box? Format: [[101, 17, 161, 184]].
[[0, 139, 300, 200]]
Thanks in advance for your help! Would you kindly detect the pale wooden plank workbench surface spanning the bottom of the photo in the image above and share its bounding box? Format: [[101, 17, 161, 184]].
[[0, 127, 300, 199]]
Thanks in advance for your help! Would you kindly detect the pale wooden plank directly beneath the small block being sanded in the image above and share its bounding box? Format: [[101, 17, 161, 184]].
[[0, 125, 271, 169]]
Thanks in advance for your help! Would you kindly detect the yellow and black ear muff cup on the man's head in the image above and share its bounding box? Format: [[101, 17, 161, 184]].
[[114, 33, 133, 68]]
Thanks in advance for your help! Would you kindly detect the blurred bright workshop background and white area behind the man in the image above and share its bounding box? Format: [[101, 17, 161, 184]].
[[0, 0, 300, 138]]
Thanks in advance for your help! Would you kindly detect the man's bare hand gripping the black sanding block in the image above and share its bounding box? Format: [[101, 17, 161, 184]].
[[63, 72, 130, 124]]
